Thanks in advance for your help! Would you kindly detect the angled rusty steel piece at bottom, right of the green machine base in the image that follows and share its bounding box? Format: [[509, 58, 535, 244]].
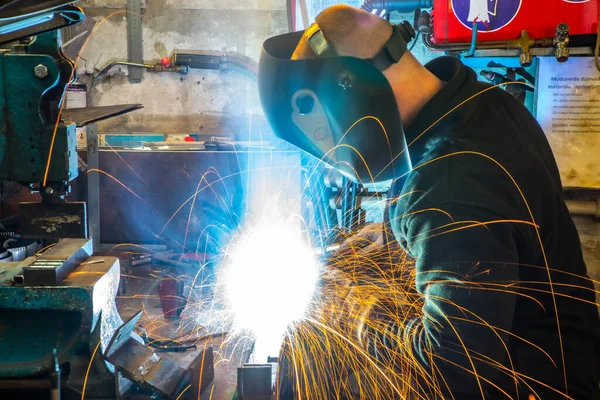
[[104, 312, 214, 398]]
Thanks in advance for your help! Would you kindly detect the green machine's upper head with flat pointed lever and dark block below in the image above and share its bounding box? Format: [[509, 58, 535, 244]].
[[0, 0, 141, 238]]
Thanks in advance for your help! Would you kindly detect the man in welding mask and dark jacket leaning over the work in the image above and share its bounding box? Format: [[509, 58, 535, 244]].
[[259, 5, 600, 400]]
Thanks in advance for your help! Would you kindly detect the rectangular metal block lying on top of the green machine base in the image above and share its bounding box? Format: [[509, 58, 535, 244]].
[[14, 239, 93, 286]]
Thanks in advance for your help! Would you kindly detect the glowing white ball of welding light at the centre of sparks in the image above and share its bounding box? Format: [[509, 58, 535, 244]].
[[225, 212, 318, 337]]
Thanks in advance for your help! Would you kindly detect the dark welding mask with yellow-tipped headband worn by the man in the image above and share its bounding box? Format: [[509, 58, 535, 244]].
[[258, 22, 414, 183]]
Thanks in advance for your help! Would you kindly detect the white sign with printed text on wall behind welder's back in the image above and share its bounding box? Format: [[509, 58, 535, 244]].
[[536, 57, 600, 188]]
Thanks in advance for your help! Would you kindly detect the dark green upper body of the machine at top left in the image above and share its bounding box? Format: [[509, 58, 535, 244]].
[[0, 1, 84, 197]]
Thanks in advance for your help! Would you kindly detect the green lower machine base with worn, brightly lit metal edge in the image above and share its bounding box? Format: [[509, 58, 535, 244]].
[[0, 253, 122, 382]]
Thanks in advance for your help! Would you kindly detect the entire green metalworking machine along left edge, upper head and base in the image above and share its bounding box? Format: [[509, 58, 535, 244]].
[[0, 0, 212, 399]]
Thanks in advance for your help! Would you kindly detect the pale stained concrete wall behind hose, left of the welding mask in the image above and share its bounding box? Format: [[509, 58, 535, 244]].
[[77, 0, 287, 138]]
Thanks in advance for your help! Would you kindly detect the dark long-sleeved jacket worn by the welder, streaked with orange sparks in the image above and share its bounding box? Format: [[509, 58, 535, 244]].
[[377, 57, 600, 400]]
